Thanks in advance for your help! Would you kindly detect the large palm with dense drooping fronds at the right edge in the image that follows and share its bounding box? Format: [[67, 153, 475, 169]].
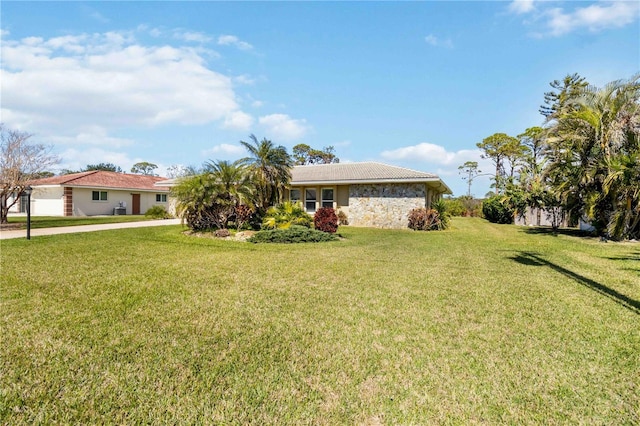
[[547, 74, 640, 239]]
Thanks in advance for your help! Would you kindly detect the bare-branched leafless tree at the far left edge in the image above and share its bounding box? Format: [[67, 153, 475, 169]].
[[0, 124, 60, 223]]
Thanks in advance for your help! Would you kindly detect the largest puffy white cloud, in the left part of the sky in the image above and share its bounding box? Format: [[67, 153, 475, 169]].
[[0, 32, 248, 146]]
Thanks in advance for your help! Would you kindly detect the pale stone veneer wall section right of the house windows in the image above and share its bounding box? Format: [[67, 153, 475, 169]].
[[348, 183, 427, 229]]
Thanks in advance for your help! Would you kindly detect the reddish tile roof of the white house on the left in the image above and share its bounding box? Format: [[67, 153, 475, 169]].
[[29, 170, 169, 192]]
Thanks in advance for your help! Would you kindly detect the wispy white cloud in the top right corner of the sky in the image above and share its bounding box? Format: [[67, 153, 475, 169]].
[[509, 0, 640, 37]]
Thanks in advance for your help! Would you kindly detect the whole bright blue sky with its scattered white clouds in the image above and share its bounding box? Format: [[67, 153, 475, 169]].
[[0, 0, 640, 196]]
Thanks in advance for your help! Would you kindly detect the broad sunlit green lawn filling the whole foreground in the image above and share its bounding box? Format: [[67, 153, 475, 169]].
[[0, 218, 640, 425]]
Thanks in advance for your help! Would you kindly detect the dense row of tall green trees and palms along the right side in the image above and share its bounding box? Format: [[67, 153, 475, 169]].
[[472, 74, 640, 240]]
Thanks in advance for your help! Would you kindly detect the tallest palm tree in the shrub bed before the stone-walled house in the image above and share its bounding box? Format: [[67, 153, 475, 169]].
[[240, 135, 293, 212]]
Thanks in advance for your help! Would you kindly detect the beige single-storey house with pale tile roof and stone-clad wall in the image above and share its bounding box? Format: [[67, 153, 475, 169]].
[[287, 162, 451, 228]]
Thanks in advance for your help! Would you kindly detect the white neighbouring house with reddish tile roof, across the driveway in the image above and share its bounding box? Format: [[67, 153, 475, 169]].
[[11, 170, 170, 216]]
